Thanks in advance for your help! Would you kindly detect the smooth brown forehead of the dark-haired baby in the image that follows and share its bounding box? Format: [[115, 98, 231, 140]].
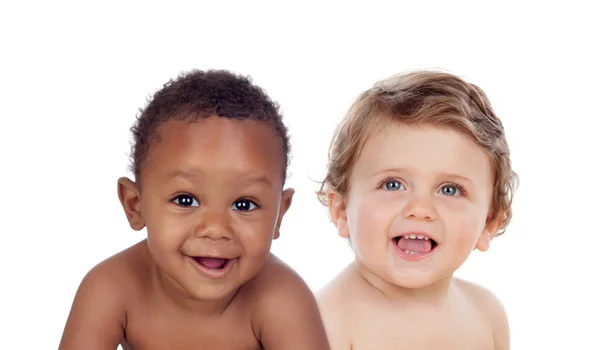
[[141, 117, 285, 186]]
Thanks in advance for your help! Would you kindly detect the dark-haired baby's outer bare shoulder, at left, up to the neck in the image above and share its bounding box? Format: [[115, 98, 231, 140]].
[[59, 242, 149, 350]]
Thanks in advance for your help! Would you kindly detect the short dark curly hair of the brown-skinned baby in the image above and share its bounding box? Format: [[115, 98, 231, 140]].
[[129, 70, 290, 181]]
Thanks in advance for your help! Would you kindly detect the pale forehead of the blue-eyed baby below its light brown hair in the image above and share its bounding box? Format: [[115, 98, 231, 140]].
[[354, 121, 491, 181]]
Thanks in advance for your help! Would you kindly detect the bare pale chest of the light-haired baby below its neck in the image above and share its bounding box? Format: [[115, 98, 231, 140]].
[[350, 304, 494, 350]]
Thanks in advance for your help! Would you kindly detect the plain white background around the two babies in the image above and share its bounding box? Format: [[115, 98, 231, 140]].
[[0, 1, 600, 350]]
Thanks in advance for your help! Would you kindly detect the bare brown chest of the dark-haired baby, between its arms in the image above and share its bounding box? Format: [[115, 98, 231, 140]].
[[121, 307, 262, 350]]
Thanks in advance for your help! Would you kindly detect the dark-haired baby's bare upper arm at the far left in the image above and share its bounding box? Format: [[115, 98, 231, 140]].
[[59, 263, 125, 350]]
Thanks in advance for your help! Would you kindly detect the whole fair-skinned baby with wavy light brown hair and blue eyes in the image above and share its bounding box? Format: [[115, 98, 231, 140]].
[[318, 71, 518, 350]]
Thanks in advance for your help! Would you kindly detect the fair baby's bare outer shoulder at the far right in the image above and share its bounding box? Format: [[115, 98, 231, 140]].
[[454, 278, 510, 350]]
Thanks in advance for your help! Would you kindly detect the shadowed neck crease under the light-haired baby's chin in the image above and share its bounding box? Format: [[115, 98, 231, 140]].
[[352, 262, 452, 305]]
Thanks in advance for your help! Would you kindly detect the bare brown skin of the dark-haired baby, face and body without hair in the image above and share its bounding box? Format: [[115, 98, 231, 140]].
[[59, 117, 329, 350]]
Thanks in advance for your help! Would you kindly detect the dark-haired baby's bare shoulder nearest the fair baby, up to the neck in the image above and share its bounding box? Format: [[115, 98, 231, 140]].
[[248, 255, 329, 350]]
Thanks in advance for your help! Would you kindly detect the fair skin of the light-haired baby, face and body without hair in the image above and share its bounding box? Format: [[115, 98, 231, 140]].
[[318, 121, 509, 350]]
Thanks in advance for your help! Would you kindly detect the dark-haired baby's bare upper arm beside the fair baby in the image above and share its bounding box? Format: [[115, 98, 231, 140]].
[[252, 262, 330, 350]]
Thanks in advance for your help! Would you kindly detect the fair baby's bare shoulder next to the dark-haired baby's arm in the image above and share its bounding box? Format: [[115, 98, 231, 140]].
[[317, 266, 360, 350]]
